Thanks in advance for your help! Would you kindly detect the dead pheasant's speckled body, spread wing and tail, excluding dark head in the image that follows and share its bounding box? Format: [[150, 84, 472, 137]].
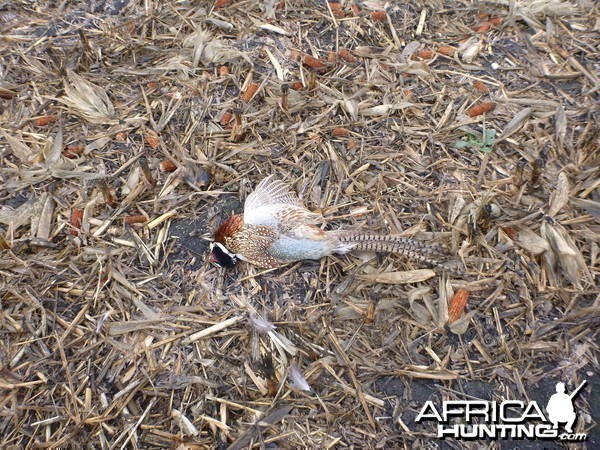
[[215, 177, 464, 273]]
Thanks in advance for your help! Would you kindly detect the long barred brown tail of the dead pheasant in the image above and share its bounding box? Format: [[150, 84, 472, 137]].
[[338, 233, 464, 276]]
